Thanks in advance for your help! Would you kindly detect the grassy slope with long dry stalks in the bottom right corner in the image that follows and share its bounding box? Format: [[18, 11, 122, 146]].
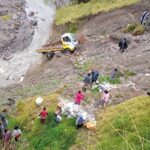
[[71, 96, 150, 150]]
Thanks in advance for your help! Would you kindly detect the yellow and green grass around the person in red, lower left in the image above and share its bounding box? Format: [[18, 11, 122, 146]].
[[9, 91, 76, 150]]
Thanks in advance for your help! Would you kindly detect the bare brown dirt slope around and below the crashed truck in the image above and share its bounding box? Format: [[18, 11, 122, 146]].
[[0, 2, 150, 106]]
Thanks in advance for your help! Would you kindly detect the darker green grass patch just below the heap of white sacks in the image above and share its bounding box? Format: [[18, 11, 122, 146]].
[[29, 115, 76, 150]]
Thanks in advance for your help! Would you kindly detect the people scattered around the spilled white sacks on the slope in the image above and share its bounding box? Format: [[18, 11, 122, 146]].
[[39, 69, 110, 129]]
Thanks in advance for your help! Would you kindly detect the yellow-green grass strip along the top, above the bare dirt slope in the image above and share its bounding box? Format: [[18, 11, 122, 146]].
[[55, 0, 139, 25]]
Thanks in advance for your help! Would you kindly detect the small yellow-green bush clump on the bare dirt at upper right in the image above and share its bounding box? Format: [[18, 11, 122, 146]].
[[123, 23, 145, 35]]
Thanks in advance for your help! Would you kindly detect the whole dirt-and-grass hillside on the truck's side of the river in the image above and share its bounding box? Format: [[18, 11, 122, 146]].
[[0, 0, 150, 150]]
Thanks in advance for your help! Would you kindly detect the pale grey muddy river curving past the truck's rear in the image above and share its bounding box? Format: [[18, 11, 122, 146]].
[[0, 0, 55, 87]]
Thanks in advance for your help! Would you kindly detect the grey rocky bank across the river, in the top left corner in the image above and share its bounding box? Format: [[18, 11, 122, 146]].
[[0, 0, 34, 59]]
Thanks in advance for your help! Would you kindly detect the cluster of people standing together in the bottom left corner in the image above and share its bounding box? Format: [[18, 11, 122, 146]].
[[0, 114, 21, 150]]
